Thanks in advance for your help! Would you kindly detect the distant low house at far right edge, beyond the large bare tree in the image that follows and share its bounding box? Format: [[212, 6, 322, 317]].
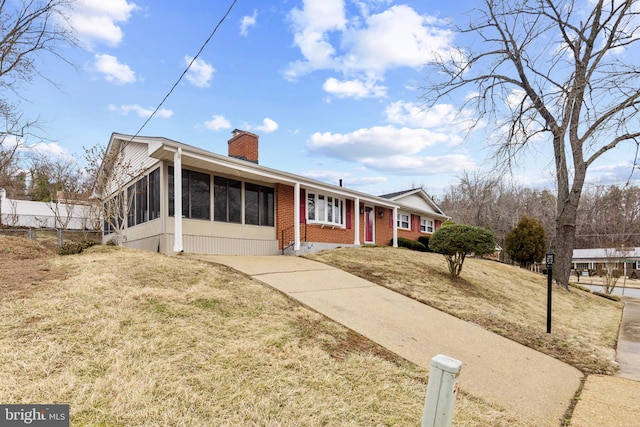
[[571, 248, 640, 278]]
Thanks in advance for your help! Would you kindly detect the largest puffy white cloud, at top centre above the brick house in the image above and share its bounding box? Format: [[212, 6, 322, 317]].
[[284, 0, 454, 97]]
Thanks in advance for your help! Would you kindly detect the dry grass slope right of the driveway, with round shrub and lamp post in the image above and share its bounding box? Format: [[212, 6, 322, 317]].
[[309, 247, 622, 374]]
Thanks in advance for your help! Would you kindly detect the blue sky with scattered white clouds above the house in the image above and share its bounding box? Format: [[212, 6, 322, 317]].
[[10, 0, 633, 194]]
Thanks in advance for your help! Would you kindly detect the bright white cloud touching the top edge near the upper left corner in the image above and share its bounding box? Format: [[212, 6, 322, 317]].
[[68, 0, 139, 48]]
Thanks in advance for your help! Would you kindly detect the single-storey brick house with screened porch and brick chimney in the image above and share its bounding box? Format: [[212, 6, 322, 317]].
[[94, 129, 448, 255]]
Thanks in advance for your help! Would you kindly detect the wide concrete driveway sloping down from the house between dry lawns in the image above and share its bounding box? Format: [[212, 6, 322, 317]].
[[198, 255, 583, 426]]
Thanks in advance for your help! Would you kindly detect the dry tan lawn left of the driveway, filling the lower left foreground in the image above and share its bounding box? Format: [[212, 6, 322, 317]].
[[0, 247, 522, 426]]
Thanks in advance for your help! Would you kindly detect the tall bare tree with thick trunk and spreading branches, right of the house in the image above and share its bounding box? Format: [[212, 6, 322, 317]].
[[425, 0, 640, 287]]
